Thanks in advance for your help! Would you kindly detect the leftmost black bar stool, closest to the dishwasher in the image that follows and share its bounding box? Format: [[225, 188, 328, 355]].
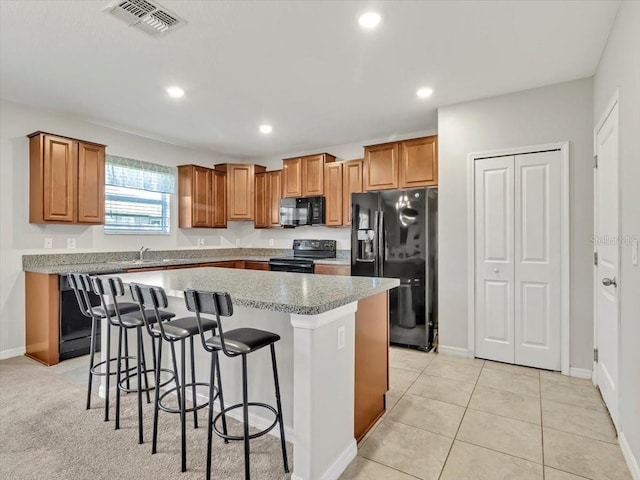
[[67, 273, 138, 422]]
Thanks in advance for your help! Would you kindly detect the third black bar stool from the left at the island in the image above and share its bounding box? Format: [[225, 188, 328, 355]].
[[129, 283, 218, 472]]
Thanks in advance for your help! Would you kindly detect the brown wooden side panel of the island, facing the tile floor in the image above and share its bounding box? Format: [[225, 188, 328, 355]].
[[354, 292, 389, 442]]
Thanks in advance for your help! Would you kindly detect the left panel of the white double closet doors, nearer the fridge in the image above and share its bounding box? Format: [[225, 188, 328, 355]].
[[475, 156, 514, 363]]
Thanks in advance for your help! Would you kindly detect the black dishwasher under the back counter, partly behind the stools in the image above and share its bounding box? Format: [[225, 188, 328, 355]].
[[58, 272, 102, 361]]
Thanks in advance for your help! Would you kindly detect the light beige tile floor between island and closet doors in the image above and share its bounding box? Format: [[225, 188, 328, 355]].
[[341, 348, 631, 480]]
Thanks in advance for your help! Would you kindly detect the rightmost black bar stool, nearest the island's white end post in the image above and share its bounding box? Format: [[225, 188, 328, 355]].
[[184, 289, 289, 480]]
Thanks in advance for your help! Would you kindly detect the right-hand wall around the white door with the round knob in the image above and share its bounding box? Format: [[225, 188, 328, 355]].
[[593, 1, 640, 472]]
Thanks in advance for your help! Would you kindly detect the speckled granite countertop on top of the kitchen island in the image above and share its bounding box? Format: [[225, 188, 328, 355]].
[[114, 267, 400, 315]]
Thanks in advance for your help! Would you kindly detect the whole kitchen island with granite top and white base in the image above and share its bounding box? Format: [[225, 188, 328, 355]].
[[112, 268, 398, 480]]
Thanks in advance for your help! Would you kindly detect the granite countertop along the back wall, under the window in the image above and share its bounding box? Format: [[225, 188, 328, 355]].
[[23, 253, 351, 275]]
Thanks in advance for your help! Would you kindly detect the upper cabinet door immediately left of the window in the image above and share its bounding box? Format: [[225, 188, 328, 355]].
[[78, 142, 104, 223]]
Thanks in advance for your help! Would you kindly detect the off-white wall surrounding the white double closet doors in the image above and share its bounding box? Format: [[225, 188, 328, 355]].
[[438, 78, 593, 369]]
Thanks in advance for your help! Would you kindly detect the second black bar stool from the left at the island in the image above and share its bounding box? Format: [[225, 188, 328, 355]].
[[92, 277, 175, 443]]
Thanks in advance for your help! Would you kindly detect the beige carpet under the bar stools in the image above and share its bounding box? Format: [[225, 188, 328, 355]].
[[0, 357, 293, 480]]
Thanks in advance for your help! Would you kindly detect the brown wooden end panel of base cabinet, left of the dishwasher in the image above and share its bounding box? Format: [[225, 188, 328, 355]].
[[24, 272, 60, 365]]
